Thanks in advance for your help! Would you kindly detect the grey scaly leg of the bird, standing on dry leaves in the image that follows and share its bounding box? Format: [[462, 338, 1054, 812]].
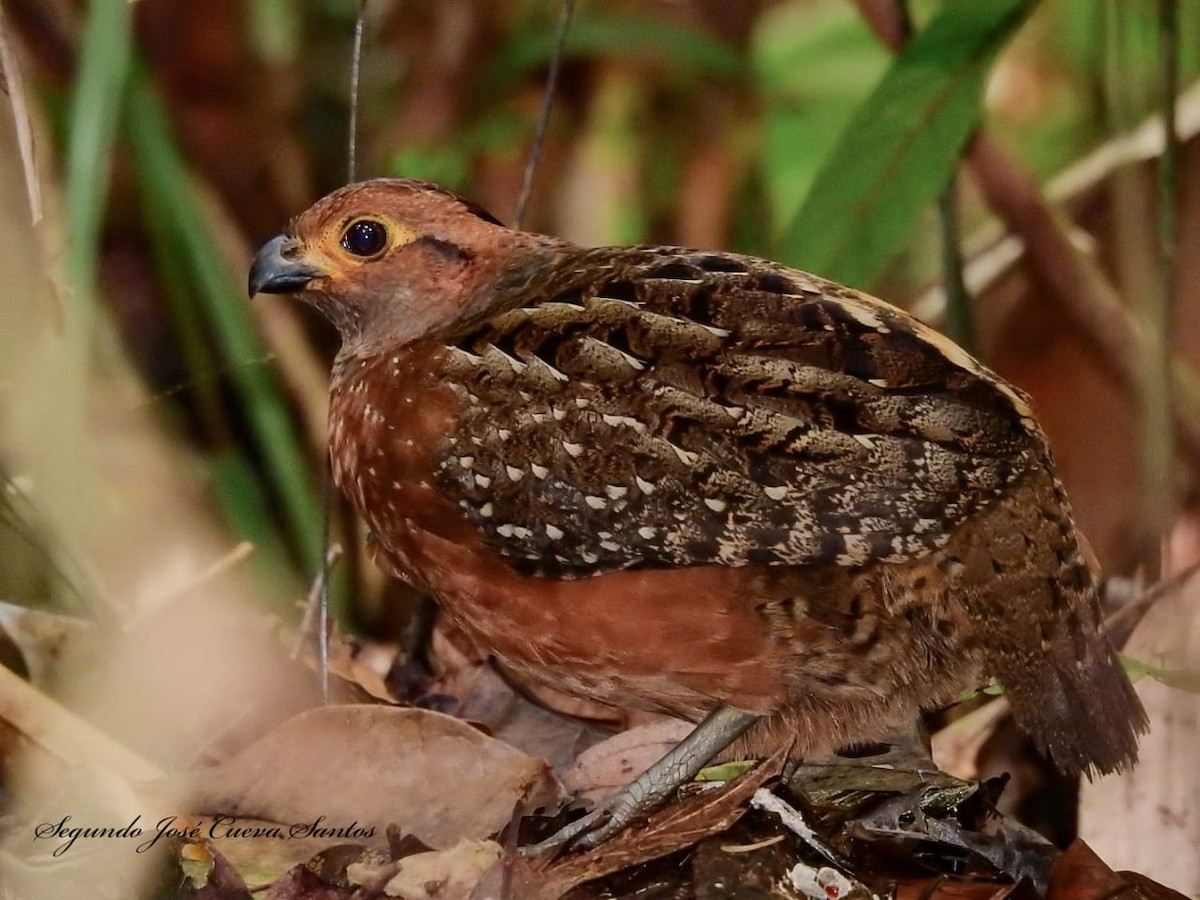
[[522, 706, 760, 856]]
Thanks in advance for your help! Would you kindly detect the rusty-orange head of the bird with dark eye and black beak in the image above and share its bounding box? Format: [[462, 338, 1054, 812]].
[[248, 179, 545, 352]]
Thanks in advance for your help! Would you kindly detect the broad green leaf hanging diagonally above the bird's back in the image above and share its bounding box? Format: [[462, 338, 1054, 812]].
[[780, 0, 1036, 286]]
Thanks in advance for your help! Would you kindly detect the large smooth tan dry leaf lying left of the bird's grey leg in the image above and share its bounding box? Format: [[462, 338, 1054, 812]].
[[190, 706, 560, 848]]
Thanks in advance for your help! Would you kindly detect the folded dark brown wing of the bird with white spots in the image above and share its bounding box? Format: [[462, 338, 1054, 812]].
[[438, 248, 1045, 577]]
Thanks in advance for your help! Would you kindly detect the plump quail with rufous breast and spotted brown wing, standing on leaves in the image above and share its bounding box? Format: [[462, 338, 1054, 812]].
[[250, 179, 1146, 845]]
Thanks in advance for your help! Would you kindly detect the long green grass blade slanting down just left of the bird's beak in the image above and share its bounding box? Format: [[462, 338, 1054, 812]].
[[126, 71, 322, 609]]
